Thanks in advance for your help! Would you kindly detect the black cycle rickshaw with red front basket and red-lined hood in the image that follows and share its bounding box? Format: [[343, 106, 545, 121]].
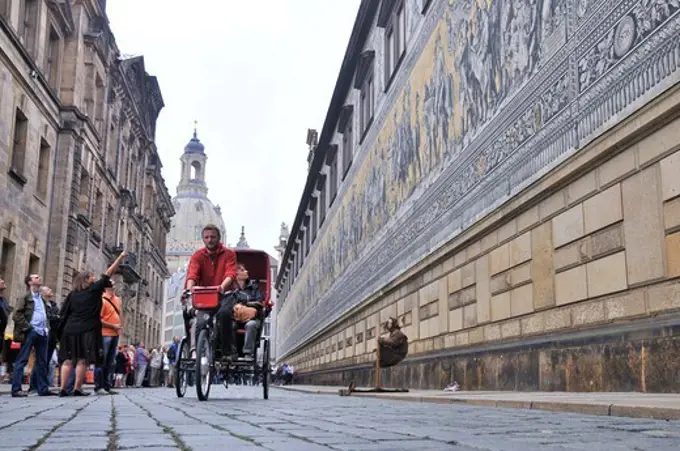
[[175, 249, 273, 401]]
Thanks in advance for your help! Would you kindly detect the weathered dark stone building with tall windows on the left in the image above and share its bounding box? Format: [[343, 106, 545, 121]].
[[0, 0, 174, 344]]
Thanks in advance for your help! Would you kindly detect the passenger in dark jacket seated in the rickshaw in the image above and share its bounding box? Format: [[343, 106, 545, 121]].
[[228, 264, 263, 360]]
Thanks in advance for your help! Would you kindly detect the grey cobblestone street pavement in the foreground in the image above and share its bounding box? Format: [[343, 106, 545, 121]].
[[0, 386, 680, 451]]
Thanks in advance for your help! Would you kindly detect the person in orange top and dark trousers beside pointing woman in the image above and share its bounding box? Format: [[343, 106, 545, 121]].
[[94, 280, 122, 395]]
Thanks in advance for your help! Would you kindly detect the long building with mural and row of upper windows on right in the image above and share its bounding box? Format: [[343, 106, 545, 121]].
[[277, 0, 680, 391]]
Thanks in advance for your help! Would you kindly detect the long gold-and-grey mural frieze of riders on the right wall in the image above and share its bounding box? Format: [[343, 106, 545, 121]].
[[279, 0, 680, 355]]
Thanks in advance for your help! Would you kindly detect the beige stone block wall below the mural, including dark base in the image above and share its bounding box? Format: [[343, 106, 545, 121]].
[[289, 88, 680, 392]]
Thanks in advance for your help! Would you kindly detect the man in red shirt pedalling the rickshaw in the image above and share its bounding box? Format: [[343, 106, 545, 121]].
[[185, 224, 238, 358]]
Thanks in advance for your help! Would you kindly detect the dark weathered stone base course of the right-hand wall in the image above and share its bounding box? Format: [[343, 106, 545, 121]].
[[298, 314, 680, 393]]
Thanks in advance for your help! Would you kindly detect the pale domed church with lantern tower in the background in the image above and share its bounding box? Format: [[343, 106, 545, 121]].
[[163, 130, 227, 343]]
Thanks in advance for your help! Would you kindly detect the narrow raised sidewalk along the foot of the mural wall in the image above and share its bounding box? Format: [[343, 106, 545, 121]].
[[276, 385, 680, 420]]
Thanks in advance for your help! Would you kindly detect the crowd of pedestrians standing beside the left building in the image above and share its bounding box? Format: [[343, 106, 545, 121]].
[[0, 252, 186, 397]]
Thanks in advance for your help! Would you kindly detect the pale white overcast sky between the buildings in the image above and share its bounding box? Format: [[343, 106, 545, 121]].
[[107, 0, 360, 254]]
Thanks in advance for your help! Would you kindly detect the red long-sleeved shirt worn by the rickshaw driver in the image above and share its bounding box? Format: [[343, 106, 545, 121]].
[[184, 243, 236, 287]]
